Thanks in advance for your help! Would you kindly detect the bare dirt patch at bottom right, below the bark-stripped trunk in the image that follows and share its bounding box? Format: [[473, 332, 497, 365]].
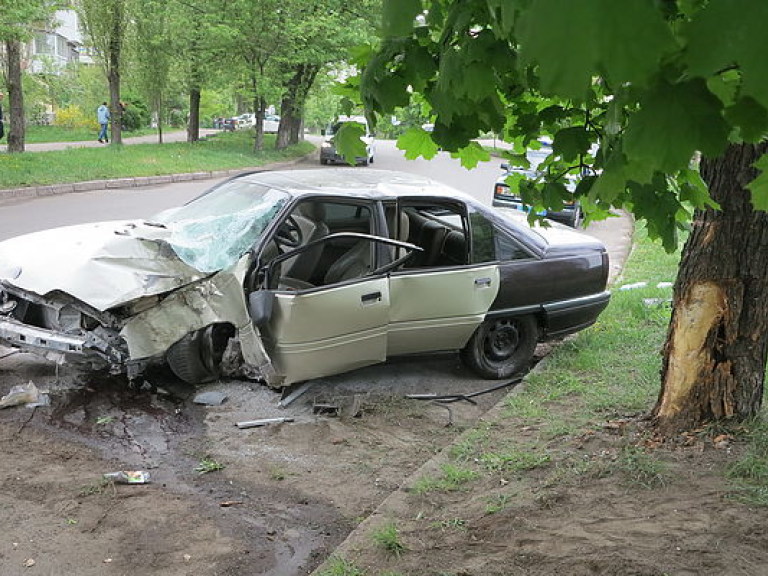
[[328, 402, 768, 576]]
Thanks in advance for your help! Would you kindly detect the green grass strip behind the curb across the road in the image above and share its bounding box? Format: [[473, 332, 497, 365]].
[[0, 132, 314, 189]]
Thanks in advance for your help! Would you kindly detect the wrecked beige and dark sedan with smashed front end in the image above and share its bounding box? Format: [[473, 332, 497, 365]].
[[0, 168, 609, 387]]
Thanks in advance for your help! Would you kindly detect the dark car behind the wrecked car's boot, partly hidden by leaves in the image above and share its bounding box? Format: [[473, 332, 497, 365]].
[[493, 144, 583, 228]]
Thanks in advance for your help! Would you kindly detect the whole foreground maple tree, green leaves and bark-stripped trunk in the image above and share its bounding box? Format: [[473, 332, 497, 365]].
[[362, 0, 768, 433]]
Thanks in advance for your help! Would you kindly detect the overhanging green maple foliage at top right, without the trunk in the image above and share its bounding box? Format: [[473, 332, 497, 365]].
[[361, 0, 768, 249]]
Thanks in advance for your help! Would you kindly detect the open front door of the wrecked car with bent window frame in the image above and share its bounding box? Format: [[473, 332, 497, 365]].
[[250, 233, 416, 386]]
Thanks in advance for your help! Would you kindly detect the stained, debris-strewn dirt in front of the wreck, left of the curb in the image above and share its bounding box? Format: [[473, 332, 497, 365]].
[[0, 349, 520, 576]]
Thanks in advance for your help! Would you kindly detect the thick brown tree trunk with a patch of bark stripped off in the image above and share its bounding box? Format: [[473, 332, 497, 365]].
[[653, 143, 768, 434]]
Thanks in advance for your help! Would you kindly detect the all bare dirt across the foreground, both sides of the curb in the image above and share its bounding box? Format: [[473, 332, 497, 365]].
[[0, 346, 768, 576]]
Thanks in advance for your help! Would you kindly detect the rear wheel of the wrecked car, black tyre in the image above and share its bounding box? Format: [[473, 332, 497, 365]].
[[461, 316, 539, 380]]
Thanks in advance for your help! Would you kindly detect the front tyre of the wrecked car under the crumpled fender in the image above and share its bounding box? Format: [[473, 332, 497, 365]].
[[170, 325, 234, 384]]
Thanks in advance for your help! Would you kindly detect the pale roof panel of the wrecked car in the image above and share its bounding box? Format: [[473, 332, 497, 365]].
[[236, 167, 476, 204]]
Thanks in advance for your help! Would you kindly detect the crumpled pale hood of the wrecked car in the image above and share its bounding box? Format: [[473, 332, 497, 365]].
[[0, 221, 209, 311]]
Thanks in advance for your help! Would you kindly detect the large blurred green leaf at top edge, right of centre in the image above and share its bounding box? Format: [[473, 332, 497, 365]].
[[518, 0, 676, 100]]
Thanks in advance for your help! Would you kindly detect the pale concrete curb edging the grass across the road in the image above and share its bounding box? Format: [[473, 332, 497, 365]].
[[0, 152, 314, 206]]
